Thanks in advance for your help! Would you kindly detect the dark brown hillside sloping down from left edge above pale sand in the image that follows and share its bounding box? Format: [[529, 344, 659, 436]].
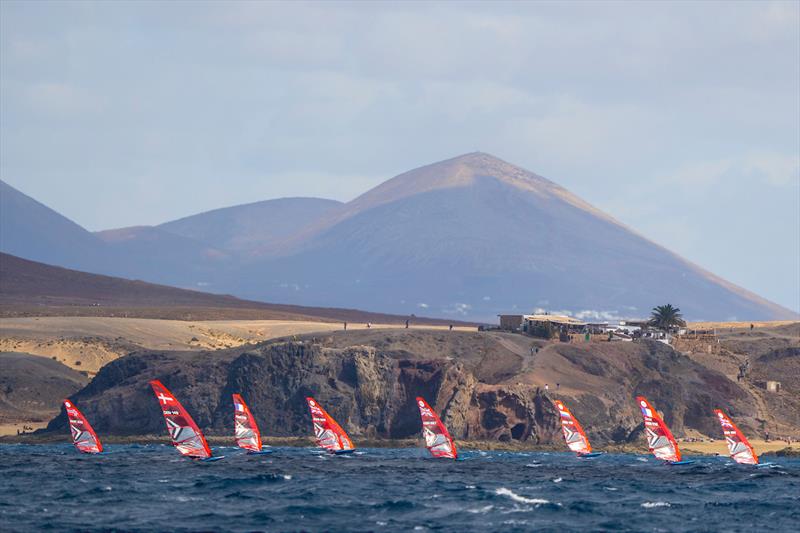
[[0, 253, 462, 324]]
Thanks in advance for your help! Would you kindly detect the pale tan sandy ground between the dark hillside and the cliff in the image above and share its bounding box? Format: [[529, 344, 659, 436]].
[[0, 317, 475, 375]]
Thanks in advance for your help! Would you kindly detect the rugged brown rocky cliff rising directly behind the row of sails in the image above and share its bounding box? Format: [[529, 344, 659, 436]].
[[40, 330, 793, 444]]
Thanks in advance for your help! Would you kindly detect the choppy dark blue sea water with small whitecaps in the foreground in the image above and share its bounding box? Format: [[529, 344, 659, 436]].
[[0, 445, 800, 532]]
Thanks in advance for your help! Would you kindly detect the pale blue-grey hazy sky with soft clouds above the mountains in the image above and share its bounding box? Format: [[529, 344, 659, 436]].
[[0, 1, 800, 310]]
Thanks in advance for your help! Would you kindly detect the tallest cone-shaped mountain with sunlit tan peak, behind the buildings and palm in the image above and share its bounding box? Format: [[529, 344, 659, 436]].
[[236, 153, 793, 320]]
